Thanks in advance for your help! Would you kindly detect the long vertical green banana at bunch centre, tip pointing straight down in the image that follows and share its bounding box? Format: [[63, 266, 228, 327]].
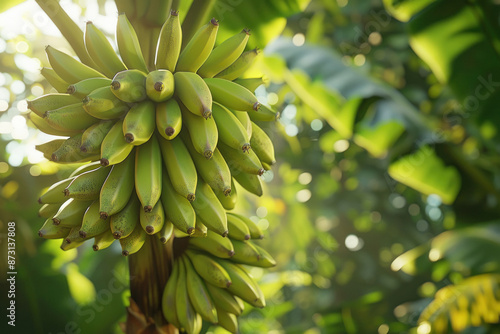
[[135, 137, 162, 212]]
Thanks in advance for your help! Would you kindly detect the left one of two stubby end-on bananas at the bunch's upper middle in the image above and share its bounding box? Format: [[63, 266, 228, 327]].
[[111, 69, 147, 103]]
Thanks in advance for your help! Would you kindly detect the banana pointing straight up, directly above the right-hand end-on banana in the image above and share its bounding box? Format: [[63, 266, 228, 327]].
[[155, 10, 182, 73]]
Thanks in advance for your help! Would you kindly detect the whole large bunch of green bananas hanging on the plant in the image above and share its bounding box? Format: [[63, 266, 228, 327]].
[[32, 11, 278, 333]]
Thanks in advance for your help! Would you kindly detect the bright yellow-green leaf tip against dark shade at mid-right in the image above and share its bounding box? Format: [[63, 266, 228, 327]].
[[389, 146, 461, 204]]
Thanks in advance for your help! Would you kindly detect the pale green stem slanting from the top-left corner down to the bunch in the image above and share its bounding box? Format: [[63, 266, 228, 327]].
[[36, 0, 97, 68]]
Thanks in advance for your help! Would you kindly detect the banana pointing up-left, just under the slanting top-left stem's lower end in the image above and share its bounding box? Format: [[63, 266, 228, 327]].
[[45, 45, 104, 84]]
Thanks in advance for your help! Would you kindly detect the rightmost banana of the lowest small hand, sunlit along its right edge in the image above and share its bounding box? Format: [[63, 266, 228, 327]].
[[217, 259, 265, 307]]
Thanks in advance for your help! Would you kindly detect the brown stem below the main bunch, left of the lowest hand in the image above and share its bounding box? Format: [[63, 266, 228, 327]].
[[126, 236, 178, 334]]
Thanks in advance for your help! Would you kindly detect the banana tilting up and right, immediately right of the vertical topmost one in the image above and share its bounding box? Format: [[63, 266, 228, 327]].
[[175, 19, 219, 73]]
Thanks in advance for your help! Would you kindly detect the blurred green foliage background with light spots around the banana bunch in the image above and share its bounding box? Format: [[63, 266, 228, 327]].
[[0, 0, 500, 334]]
